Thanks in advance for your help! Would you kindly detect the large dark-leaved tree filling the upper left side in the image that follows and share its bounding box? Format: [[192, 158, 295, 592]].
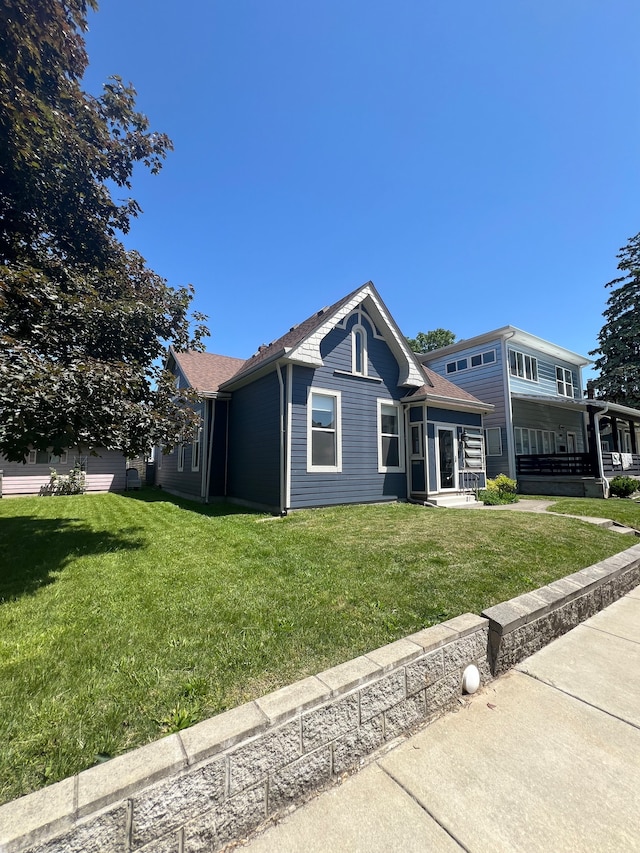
[[0, 0, 207, 460]]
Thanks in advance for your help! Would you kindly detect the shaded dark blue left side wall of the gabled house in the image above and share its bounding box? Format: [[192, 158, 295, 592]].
[[227, 370, 280, 510]]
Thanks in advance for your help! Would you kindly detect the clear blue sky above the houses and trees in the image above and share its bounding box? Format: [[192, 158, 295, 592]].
[[84, 0, 640, 380]]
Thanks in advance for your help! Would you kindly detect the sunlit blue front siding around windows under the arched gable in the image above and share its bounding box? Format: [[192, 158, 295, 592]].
[[291, 319, 407, 508]]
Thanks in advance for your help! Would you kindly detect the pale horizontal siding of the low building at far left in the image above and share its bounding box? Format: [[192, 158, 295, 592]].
[[0, 450, 127, 497]]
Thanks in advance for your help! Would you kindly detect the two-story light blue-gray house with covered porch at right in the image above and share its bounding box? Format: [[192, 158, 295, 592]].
[[420, 326, 640, 497]]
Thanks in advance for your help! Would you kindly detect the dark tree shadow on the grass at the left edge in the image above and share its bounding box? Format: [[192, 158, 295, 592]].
[[0, 515, 143, 605]]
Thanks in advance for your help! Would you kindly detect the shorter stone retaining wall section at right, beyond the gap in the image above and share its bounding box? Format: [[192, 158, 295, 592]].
[[482, 545, 640, 675]]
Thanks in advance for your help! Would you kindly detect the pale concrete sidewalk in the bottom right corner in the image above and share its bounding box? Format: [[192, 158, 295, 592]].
[[241, 587, 640, 853]]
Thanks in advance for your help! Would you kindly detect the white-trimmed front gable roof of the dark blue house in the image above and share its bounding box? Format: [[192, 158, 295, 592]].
[[225, 281, 424, 388]]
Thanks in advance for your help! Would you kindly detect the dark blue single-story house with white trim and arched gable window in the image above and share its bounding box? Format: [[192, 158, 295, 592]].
[[156, 282, 492, 513]]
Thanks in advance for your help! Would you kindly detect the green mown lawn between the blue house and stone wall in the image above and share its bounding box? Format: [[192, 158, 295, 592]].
[[0, 490, 631, 801]]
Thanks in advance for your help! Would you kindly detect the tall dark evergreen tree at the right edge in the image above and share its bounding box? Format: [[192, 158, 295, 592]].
[[590, 234, 640, 408]]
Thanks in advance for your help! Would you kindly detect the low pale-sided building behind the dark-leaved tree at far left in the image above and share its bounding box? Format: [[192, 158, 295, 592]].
[[0, 448, 127, 497]]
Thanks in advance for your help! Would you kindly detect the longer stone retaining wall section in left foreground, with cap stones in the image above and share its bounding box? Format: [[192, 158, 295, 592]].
[[0, 613, 491, 853]]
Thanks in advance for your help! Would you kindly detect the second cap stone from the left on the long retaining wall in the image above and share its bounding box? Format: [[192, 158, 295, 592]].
[[78, 734, 187, 817]]
